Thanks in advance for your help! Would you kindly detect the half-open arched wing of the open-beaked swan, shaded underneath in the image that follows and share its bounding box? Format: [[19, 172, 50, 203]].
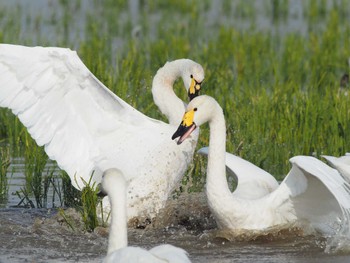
[[271, 156, 350, 233]]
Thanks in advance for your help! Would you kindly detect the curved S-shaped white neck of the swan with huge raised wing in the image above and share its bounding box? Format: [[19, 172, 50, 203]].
[[152, 59, 186, 125]]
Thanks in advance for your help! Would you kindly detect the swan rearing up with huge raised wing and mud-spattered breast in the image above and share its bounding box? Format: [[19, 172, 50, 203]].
[[0, 44, 204, 222]]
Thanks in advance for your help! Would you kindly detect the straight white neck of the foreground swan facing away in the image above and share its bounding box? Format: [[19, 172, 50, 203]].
[[108, 179, 128, 254]]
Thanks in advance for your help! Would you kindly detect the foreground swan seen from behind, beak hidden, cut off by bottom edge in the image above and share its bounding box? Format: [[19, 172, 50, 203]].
[[102, 168, 190, 263]]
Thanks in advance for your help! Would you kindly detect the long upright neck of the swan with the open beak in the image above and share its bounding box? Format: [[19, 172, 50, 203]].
[[206, 108, 233, 214]]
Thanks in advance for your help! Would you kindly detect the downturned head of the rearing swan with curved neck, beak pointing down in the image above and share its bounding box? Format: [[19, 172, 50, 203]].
[[182, 59, 204, 101]]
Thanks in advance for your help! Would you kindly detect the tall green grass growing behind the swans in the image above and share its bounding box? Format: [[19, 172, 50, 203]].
[[0, 0, 350, 228]]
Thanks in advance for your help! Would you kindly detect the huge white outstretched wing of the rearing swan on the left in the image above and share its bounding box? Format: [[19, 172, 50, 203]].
[[0, 44, 165, 188]]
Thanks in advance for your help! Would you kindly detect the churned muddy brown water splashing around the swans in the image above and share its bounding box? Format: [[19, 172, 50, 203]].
[[0, 194, 350, 263]]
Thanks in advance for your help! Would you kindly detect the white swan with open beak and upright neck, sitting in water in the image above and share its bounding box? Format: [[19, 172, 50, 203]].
[[173, 96, 350, 234]]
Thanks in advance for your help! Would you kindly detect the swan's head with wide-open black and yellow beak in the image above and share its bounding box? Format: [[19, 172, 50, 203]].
[[171, 95, 217, 144]]
